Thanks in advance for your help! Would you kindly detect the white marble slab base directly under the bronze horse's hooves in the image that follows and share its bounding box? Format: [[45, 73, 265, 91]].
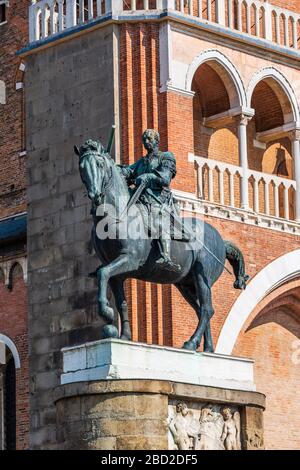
[[61, 339, 256, 391]]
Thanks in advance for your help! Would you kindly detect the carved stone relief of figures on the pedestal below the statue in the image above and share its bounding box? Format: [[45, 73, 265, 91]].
[[168, 401, 241, 450]]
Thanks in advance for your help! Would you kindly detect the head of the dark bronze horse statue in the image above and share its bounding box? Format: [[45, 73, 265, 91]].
[[74, 139, 107, 206]]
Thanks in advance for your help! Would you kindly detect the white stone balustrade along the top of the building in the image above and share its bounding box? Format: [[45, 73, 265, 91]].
[[30, 0, 300, 49]]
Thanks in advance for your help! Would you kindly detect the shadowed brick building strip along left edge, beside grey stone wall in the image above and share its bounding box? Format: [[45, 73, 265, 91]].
[[0, 0, 31, 449]]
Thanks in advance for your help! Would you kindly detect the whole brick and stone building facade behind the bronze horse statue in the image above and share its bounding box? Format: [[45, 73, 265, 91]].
[[0, 0, 300, 449]]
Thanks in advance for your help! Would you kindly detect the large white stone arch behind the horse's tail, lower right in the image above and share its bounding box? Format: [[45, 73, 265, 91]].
[[216, 249, 300, 354]]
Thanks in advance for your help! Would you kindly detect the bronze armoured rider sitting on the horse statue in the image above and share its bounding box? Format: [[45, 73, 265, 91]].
[[120, 129, 181, 272]]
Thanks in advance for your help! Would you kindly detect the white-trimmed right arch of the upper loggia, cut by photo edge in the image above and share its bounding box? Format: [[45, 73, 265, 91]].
[[247, 67, 300, 123]]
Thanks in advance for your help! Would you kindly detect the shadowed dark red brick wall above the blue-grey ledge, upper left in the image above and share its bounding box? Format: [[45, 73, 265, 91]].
[[0, 0, 31, 218]]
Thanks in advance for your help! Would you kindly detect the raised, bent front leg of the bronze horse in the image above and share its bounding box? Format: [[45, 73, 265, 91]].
[[97, 254, 129, 324]]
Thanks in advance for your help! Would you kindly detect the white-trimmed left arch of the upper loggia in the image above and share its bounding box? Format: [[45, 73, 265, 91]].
[[185, 49, 247, 108]]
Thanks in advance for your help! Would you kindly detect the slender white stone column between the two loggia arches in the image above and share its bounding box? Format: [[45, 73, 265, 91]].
[[238, 114, 251, 210]]
